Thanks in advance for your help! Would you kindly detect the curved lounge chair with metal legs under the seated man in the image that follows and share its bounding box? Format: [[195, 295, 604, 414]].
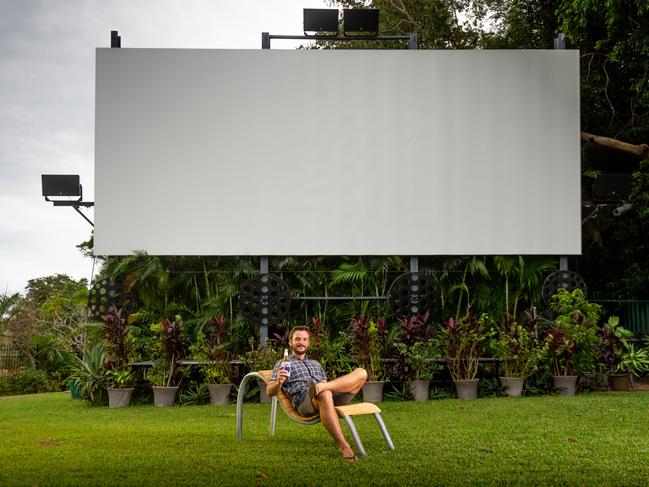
[[237, 370, 394, 456]]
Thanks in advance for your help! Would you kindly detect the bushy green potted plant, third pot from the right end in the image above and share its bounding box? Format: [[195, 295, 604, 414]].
[[494, 314, 544, 397]]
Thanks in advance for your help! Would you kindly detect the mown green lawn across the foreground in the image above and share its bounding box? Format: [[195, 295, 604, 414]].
[[0, 393, 649, 486]]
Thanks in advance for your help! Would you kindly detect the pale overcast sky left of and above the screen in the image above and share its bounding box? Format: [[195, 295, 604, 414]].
[[0, 0, 328, 293]]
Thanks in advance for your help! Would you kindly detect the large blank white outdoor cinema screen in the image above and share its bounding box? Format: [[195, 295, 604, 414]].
[[95, 49, 581, 255]]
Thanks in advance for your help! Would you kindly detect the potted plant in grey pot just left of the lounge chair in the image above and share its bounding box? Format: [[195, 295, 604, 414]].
[[196, 316, 232, 405]]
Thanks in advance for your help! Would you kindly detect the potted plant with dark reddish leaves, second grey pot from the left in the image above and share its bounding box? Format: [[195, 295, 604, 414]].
[[148, 316, 186, 407]]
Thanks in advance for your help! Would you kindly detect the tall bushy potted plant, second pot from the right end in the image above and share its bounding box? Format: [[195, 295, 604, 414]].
[[544, 289, 600, 396]]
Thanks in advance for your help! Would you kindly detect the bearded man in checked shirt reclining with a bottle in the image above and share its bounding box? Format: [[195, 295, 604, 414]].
[[266, 326, 367, 462]]
